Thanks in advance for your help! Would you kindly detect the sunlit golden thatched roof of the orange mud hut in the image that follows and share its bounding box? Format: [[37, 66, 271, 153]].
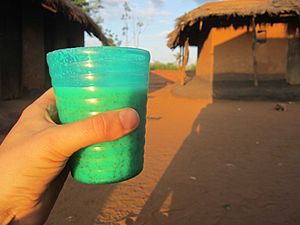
[[167, 0, 300, 48]]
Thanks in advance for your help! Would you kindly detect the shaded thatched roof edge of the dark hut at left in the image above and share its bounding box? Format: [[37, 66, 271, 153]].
[[40, 0, 113, 45]]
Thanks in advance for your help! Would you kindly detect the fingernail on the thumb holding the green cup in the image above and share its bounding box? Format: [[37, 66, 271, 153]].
[[119, 108, 140, 130]]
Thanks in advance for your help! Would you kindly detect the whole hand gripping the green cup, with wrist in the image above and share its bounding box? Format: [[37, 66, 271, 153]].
[[0, 89, 139, 225]]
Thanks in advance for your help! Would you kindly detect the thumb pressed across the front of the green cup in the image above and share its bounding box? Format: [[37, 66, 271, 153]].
[[48, 108, 140, 157]]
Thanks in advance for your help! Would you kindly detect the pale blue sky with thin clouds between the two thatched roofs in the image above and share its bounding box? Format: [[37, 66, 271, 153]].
[[85, 0, 216, 64]]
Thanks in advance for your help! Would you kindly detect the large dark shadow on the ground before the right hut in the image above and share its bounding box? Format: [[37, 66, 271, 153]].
[[135, 101, 300, 225]]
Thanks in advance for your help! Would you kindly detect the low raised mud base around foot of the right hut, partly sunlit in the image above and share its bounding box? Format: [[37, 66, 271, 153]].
[[172, 74, 300, 101]]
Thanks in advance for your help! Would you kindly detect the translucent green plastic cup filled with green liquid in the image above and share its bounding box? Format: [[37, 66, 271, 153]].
[[47, 46, 150, 184]]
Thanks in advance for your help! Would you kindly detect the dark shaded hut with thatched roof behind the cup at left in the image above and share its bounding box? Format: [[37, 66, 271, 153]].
[[0, 0, 111, 99]]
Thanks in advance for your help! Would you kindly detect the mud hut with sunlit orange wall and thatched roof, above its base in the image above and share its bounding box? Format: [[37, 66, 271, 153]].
[[167, 0, 300, 86]]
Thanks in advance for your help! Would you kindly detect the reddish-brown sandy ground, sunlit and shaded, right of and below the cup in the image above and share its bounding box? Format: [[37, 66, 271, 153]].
[[0, 70, 300, 225]]
